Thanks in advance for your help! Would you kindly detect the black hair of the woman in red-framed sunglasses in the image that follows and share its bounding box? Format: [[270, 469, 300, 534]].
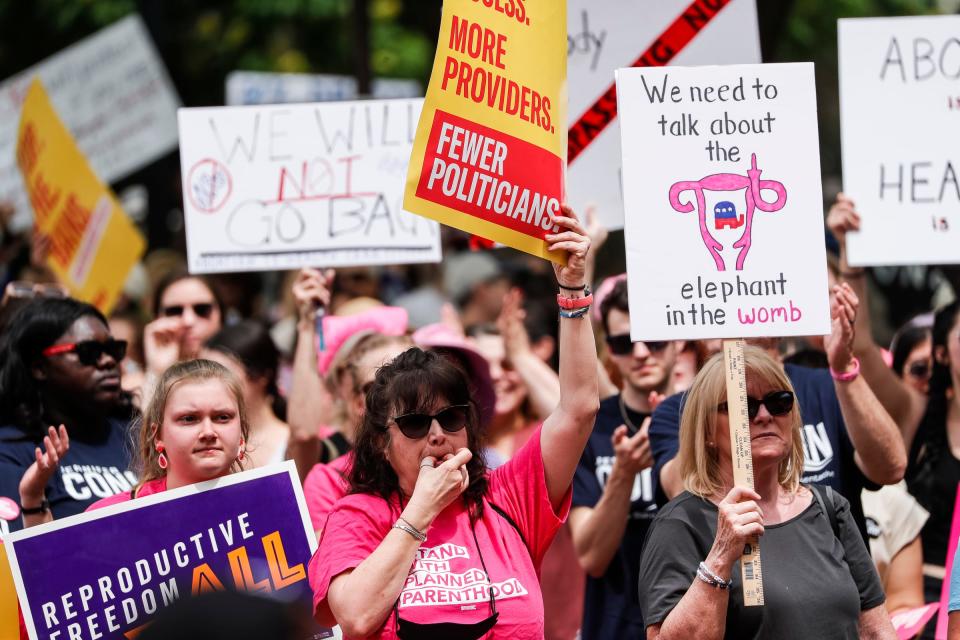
[[0, 298, 133, 435]]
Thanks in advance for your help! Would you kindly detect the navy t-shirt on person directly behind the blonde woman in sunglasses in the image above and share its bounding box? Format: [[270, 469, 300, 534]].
[[650, 364, 877, 540]]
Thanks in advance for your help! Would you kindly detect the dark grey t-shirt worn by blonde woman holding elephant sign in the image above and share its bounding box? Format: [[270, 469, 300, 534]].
[[640, 491, 884, 640]]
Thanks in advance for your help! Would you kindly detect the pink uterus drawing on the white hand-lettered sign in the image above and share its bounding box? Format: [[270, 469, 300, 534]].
[[670, 153, 787, 271]]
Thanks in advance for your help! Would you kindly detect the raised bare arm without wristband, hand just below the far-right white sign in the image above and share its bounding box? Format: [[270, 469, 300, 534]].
[[827, 193, 926, 451]]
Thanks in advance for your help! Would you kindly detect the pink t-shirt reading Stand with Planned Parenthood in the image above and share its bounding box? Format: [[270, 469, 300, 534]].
[[310, 430, 571, 640]]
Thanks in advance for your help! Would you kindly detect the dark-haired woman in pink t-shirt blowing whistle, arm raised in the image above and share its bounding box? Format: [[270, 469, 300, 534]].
[[310, 208, 598, 640]]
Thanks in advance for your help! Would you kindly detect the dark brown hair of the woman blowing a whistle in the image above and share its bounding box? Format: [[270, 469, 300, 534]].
[[349, 347, 487, 520]]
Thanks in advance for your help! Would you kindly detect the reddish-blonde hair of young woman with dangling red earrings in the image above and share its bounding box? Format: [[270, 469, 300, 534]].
[[134, 360, 250, 491]]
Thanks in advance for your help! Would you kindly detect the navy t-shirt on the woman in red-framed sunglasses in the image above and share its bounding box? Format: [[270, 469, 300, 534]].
[[0, 418, 137, 531]]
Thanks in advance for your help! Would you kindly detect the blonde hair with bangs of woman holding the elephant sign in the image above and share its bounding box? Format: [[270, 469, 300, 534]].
[[677, 345, 803, 498]]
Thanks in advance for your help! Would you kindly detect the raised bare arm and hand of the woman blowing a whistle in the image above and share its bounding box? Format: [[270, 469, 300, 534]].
[[540, 207, 600, 509]]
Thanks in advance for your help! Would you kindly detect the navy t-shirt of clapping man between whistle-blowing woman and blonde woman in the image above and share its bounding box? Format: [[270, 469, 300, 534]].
[[572, 395, 657, 640]]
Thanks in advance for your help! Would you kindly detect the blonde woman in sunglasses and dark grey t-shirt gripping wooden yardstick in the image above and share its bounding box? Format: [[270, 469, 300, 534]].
[[640, 346, 897, 640]]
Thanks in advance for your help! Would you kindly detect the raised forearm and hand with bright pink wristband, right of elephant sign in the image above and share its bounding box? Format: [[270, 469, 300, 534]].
[[824, 284, 907, 484]]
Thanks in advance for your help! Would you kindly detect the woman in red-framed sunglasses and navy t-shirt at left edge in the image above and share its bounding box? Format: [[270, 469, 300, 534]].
[[0, 298, 136, 524]]
